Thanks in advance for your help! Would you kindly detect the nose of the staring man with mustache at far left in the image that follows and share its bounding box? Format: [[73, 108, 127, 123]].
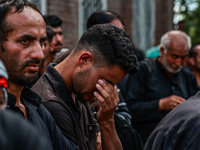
[[30, 42, 44, 60]]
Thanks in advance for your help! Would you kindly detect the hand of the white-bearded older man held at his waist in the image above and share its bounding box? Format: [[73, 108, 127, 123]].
[[159, 95, 185, 111]]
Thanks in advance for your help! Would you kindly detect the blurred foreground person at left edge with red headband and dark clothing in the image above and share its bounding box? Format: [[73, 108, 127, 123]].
[[0, 60, 52, 150]]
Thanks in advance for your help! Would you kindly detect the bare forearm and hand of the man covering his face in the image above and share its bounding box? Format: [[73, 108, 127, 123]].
[[94, 80, 123, 150]]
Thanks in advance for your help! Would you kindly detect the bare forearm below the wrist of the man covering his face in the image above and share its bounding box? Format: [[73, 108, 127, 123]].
[[99, 119, 123, 150]]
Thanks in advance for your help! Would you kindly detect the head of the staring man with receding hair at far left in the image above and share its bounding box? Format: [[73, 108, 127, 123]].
[[0, 0, 46, 86]]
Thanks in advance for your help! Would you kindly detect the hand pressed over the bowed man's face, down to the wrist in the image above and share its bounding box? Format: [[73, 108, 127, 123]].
[[94, 79, 120, 123]]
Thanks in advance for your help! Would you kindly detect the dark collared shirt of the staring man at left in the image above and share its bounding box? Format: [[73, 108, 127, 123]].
[[7, 87, 77, 150]]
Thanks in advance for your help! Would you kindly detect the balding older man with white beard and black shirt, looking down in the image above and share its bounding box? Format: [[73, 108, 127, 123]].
[[120, 31, 198, 143]]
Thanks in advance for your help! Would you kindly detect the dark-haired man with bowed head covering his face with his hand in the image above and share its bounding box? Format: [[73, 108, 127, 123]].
[[32, 24, 138, 150]]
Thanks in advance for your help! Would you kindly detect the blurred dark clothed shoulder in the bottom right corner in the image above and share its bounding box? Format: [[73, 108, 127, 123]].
[[144, 92, 200, 150]]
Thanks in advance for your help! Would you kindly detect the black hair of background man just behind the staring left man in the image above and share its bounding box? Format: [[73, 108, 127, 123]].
[[43, 15, 63, 28]]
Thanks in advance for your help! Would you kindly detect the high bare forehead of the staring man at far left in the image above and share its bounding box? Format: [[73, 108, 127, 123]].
[[5, 7, 46, 34]]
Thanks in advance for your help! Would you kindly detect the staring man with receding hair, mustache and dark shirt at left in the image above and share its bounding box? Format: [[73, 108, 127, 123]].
[[0, 0, 76, 150]]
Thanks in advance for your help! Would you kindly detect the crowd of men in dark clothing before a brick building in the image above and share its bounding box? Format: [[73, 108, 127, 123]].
[[0, 0, 200, 150]]
